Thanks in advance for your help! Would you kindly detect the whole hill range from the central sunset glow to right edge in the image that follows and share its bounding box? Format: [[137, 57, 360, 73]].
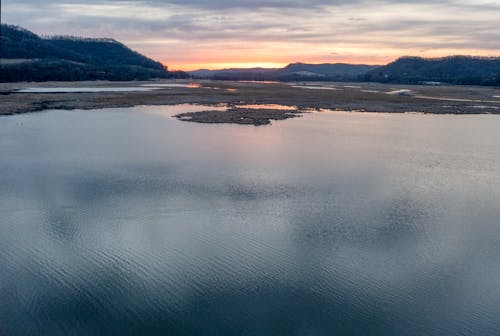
[[190, 56, 500, 85]]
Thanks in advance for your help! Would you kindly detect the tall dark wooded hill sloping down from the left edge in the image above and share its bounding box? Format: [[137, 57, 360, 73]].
[[0, 24, 180, 82]]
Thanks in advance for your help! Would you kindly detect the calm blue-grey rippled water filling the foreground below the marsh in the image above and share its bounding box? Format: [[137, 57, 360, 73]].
[[0, 106, 500, 336]]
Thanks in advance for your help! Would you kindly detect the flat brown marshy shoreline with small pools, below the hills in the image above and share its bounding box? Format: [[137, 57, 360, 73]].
[[0, 81, 500, 126]]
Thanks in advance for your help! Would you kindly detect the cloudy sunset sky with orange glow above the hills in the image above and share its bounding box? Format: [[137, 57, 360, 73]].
[[1, 0, 500, 70]]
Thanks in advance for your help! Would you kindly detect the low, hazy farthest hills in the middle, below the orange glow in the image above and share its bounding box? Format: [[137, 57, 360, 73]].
[[189, 63, 377, 81]]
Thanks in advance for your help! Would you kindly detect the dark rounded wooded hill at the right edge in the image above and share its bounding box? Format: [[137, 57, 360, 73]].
[[364, 56, 500, 85]]
